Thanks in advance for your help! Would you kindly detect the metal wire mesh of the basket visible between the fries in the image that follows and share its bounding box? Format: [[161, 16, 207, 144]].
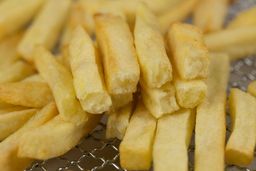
[[25, 0, 256, 171]]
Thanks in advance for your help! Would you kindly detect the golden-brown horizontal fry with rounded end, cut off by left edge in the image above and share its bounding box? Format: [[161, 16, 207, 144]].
[[0, 82, 53, 108]]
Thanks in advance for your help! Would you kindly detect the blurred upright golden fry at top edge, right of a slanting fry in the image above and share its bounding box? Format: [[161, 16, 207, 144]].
[[193, 0, 229, 33]]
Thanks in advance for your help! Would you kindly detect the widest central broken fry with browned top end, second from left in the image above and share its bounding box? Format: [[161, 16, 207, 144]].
[[95, 14, 140, 94]]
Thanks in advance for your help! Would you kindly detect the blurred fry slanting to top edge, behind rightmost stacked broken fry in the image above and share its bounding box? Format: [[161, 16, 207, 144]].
[[158, 0, 199, 33]]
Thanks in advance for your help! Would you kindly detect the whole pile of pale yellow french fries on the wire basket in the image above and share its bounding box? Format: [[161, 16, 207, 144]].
[[0, 0, 256, 171]]
